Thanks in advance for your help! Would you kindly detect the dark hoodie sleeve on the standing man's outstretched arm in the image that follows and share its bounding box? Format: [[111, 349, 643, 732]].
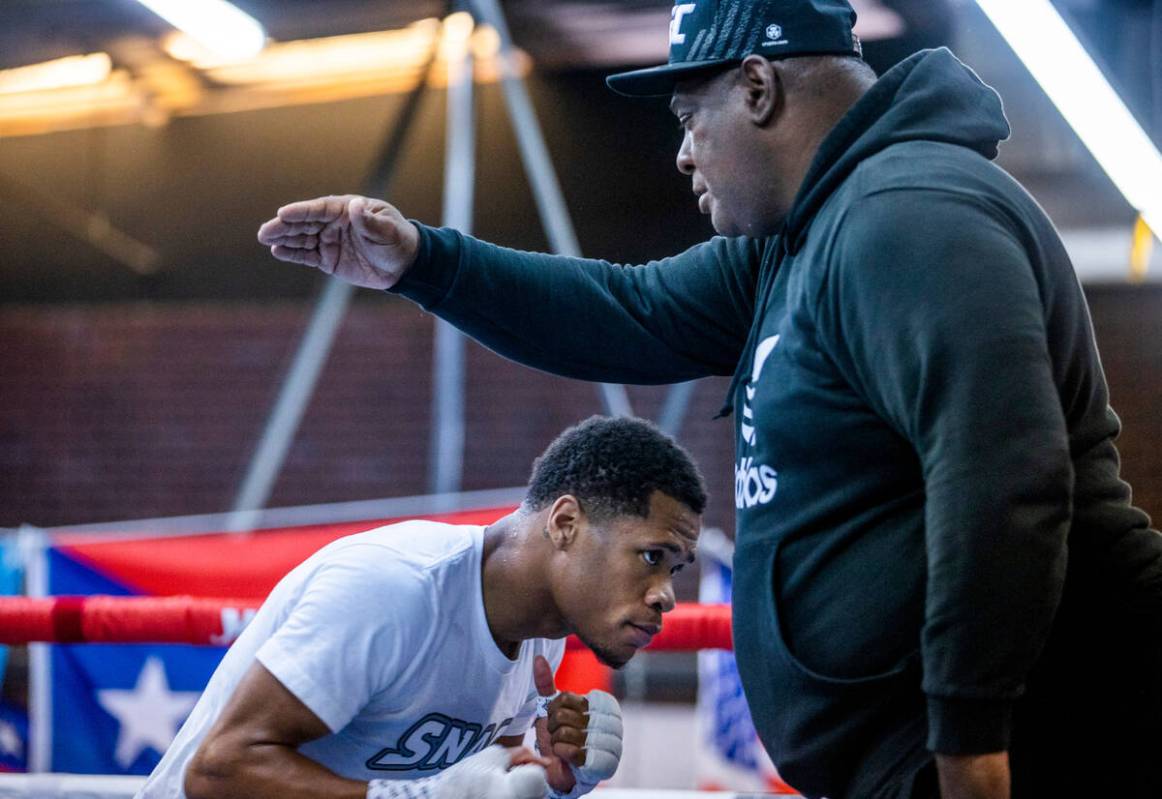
[[392, 225, 763, 383]]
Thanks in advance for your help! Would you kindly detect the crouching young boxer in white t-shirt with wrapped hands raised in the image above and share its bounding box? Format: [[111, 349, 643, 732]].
[[137, 417, 706, 799]]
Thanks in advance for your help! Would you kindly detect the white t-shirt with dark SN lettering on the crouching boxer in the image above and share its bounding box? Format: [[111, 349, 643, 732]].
[[137, 521, 565, 799]]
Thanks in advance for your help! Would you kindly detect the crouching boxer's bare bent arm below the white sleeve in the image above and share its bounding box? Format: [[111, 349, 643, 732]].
[[185, 663, 367, 799]]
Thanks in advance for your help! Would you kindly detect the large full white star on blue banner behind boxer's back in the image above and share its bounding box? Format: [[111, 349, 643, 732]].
[[96, 657, 200, 769]]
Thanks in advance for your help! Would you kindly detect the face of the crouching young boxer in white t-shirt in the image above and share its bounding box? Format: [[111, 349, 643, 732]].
[[558, 491, 702, 669]]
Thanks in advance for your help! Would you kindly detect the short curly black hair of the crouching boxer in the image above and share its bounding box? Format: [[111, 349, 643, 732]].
[[524, 416, 706, 519]]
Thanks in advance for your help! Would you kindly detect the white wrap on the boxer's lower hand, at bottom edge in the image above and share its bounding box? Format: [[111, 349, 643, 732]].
[[367, 746, 547, 799]]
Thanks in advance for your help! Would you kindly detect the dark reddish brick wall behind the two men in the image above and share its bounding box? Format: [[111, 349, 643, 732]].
[[0, 287, 1162, 530]]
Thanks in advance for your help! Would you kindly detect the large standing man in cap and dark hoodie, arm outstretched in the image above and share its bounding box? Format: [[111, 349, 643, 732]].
[[259, 0, 1162, 799]]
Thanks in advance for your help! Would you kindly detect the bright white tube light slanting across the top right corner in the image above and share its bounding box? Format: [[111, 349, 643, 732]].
[[977, 0, 1162, 235]]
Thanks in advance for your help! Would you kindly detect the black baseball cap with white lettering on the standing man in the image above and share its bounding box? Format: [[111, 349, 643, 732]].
[[605, 0, 863, 98]]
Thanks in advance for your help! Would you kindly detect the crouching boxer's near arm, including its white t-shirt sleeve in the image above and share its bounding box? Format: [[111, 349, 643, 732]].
[[186, 544, 437, 799]]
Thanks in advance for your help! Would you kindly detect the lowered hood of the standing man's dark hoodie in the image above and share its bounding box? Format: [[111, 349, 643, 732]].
[[783, 48, 1010, 253]]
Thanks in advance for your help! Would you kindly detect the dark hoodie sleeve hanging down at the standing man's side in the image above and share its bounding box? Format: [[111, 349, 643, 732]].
[[817, 189, 1074, 754]]
